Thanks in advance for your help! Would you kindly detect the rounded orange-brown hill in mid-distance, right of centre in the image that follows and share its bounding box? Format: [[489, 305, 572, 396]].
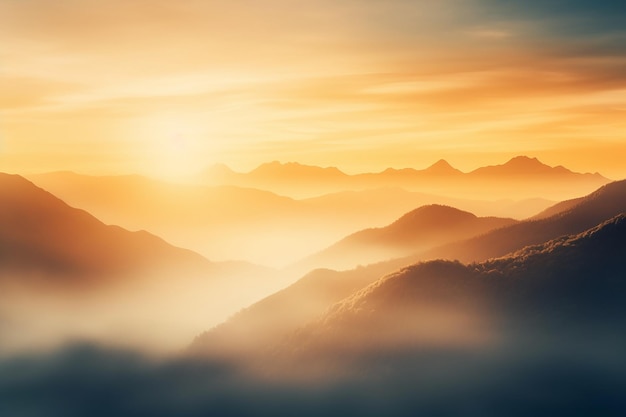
[[298, 205, 515, 269]]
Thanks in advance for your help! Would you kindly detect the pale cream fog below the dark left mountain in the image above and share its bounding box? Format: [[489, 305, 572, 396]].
[[0, 264, 284, 354]]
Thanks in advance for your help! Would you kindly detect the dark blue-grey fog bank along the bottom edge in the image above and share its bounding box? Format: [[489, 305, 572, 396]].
[[0, 322, 626, 417]]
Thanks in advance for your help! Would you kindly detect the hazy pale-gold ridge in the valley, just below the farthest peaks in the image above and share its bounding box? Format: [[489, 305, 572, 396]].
[[28, 172, 554, 266]]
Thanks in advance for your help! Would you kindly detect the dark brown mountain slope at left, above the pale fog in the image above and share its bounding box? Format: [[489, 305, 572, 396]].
[[0, 174, 212, 283]]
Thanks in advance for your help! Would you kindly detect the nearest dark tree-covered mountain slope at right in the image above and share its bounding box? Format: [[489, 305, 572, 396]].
[[286, 214, 626, 355]]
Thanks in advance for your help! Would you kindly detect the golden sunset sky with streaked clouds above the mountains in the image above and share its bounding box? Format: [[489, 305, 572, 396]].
[[0, 0, 626, 179]]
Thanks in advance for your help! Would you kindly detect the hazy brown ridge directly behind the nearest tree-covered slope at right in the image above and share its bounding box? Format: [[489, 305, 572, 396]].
[[193, 181, 626, 353]]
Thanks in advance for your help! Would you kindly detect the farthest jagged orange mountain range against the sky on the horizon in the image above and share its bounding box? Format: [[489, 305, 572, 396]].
[[203, 156, 610, 200]]
